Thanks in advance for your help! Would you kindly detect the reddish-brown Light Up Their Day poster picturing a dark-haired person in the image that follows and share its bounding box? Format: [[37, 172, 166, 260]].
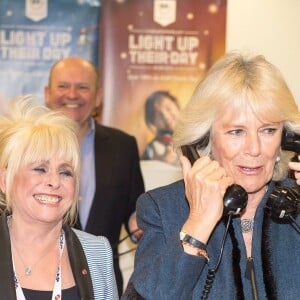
[[101, 0, 226, 188]]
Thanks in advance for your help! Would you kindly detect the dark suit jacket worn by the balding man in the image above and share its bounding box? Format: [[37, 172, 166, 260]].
[[76, 124, 145, 293]]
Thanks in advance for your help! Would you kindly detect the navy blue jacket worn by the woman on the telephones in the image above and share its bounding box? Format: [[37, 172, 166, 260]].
[[122, 180, 300, 300]]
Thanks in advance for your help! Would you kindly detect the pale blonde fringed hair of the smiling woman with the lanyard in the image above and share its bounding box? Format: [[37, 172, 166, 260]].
[[0, 96, 80, 224]]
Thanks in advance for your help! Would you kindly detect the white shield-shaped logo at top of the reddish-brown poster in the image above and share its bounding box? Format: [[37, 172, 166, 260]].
[[153, 0, 176, 26]]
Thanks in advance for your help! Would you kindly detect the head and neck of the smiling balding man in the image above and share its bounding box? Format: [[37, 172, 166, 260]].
[[45, 57, 100, 139]]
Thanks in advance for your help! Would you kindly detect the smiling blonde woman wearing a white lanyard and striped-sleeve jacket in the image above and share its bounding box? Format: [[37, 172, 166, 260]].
[[0, 98, 118, 300]]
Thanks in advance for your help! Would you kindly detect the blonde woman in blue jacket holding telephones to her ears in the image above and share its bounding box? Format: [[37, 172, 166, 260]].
[[123, 52, 300, 300]]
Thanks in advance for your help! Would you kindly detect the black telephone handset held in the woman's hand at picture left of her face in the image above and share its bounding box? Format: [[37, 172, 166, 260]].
[[181, 134, 248, 216]]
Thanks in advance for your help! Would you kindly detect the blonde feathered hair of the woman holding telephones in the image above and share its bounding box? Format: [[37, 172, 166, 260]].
[[173, 52, 300, 180]]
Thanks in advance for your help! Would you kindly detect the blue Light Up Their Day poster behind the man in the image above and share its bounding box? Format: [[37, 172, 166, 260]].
[[0, 0, 100, 104]]
